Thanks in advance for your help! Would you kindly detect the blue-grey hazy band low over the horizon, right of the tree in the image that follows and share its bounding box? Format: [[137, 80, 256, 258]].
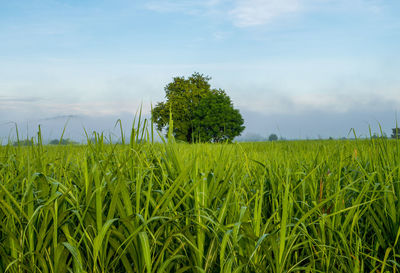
[[241, 109, 396, 139]]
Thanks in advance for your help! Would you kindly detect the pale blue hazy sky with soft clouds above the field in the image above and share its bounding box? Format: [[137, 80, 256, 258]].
[[0, 0, 400, 142]]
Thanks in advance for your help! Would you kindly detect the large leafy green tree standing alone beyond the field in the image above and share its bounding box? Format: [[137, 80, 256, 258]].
[[152, 72, 245, 143]]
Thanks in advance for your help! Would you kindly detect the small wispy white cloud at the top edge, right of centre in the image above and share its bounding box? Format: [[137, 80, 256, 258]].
[[230, 0, 302, 27]]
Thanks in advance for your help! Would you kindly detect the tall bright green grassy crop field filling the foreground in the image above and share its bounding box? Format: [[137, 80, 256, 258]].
[[0, 129, 400, 273]]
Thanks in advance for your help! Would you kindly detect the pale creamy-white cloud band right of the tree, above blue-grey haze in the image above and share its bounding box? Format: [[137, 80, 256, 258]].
[[233, 79, 400, 115]]
